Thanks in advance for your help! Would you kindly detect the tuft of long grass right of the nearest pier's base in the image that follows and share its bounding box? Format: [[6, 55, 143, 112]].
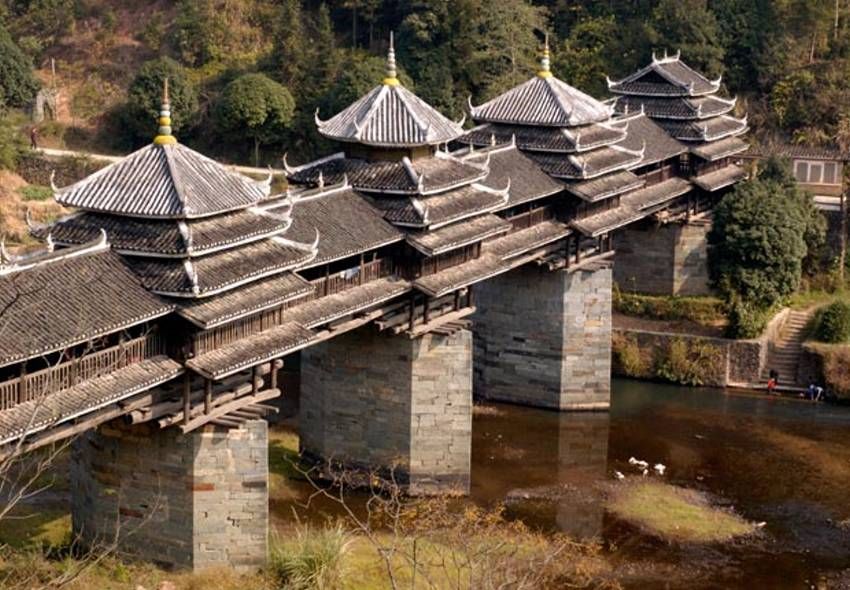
[[269, 525, 352, 590]]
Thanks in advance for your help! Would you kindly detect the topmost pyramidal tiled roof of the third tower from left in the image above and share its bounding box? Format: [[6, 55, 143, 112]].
[[470, 75, 611, 127]]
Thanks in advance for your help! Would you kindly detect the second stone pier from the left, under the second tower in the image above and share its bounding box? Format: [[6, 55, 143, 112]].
[[300, 327, 472, 494]]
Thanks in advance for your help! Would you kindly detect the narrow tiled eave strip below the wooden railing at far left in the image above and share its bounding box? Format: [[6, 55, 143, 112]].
[[0, 356, 183, 445]]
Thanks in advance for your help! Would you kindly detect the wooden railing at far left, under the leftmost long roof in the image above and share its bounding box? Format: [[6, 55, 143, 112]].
[[0, 334, 165, 410]]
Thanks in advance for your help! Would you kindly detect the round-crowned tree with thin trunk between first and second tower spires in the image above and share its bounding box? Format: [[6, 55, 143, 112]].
[[216, 74, 295, 165]]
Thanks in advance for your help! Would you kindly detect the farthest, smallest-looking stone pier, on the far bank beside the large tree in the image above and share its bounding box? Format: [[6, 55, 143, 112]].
[[614, 219, 711, 295]]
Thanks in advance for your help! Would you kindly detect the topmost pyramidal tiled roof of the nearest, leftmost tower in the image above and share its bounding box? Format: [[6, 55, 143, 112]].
[[56, 144, 268, 219]]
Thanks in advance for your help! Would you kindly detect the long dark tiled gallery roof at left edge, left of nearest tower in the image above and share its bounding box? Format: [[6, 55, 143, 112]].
[[0, 246, 173, 366]]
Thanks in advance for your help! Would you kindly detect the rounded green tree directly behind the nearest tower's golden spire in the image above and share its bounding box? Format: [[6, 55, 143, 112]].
[[121, 57, 200, 144]]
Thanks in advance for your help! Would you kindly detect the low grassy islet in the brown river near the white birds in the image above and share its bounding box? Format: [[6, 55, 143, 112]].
[[607, 481, 756, 543]]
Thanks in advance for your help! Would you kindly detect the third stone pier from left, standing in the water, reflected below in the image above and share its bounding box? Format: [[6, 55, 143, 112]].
[[473, 264, 611, 410]]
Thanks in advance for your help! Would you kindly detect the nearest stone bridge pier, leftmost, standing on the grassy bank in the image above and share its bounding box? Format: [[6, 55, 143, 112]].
[[71, 420, 269, 570]]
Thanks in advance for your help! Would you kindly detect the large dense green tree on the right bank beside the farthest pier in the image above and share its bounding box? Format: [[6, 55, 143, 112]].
[[708, 158, 826, 336]]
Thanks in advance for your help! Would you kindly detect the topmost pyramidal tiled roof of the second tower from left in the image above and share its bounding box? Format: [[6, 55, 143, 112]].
[[316, 84, 463, 147]]
